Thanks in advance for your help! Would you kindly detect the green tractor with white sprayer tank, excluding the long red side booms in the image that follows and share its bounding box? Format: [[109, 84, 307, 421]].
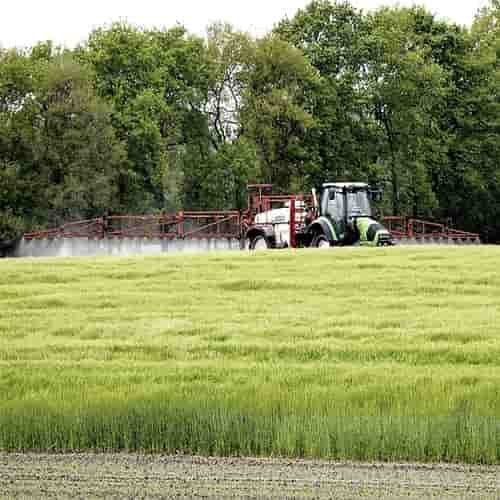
[[246, 182, 394, 250]]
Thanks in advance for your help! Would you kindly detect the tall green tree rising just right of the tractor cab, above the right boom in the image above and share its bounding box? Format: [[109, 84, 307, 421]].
[[365, 8, 449, 216]]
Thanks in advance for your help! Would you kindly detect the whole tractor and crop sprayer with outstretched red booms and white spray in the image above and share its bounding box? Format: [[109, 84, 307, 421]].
[[3, 182, 480, 257]]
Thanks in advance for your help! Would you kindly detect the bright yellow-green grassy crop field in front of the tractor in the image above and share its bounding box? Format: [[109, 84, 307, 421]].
[[0, 246, 500, 463]]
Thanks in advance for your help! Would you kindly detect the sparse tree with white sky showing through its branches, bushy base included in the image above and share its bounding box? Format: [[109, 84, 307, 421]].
[[181, 23, 260, 209]]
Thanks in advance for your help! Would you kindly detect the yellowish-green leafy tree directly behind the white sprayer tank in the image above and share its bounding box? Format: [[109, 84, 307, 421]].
[[240, 36, 319, 190]]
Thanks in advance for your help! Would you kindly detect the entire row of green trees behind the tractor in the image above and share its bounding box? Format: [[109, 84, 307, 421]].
[[0, 0, 500, 241]]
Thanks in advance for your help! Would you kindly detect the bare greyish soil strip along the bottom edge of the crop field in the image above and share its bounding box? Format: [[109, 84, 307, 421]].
[[0, 454, 500, 499]]
